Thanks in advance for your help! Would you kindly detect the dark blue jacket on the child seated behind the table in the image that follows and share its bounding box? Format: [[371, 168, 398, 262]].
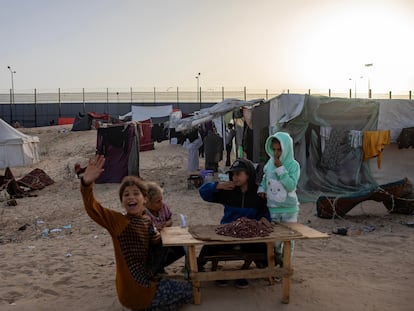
[[199, 182, 270, 224]]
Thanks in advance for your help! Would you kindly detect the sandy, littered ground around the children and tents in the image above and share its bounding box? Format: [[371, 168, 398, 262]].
[[0, 126, 414, 311]]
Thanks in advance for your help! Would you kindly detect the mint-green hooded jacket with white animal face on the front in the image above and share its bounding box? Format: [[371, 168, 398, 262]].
[[257, 132, 300, 215]]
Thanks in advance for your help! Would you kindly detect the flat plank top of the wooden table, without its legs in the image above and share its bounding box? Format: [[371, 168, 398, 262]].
[[161, 223, 329, 246]]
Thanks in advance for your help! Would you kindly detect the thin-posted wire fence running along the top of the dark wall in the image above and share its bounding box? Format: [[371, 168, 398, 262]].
[[0, 87, 412, 104]]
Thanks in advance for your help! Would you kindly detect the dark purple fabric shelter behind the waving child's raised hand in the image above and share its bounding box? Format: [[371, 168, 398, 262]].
[[96, 123, 140, 183]]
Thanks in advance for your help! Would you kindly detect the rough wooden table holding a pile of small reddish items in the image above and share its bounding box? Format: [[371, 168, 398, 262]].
[[161, 223, 329, 304]]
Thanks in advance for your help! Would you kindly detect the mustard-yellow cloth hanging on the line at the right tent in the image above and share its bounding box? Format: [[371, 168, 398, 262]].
[[362, 130, 390, 168]]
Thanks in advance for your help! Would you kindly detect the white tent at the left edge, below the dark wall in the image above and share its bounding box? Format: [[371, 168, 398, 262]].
[[0, 119, 39, 168]]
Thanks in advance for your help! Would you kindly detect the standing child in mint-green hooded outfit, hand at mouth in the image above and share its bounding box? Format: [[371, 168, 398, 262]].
[[257, 132, 300, 262]]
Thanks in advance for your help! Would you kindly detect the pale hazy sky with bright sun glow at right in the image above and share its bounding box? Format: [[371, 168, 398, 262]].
[[0, 0, 414, 92]]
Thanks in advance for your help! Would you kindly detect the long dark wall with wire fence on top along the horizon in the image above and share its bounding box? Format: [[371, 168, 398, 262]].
[[0, 87, 412, 127]]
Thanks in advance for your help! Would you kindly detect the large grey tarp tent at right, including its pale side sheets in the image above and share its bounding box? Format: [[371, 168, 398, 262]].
[[269, 94, 414, 202]]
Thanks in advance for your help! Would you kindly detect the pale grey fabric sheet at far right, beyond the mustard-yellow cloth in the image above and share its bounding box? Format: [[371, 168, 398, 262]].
[[378, 99, 414, 143]]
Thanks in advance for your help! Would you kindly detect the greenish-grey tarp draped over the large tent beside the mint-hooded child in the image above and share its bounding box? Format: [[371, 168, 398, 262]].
[[270, 95, 380, 202]]
